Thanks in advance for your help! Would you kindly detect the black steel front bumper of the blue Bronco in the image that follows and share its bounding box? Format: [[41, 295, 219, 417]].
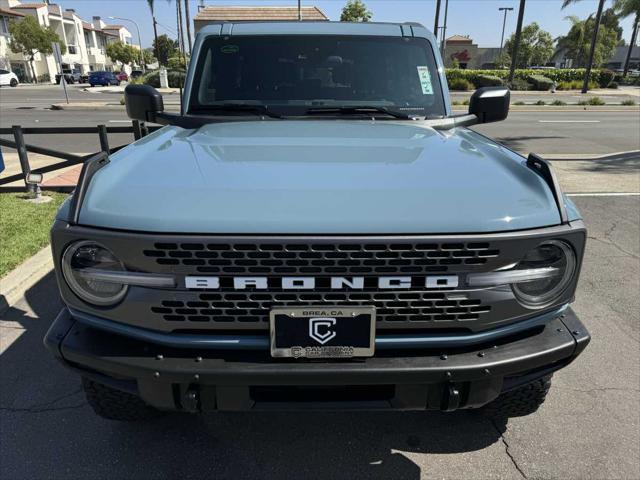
[[44, 308, 590, 411]]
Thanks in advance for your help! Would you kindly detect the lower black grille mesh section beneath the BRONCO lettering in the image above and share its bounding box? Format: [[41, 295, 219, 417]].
[[151, 292, 491, 328]]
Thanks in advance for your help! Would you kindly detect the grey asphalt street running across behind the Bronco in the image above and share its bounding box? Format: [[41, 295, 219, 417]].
[[0, 85, 640, 155]]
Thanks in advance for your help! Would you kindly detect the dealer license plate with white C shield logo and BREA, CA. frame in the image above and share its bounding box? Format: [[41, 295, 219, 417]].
[[270, 306, 376, 358]]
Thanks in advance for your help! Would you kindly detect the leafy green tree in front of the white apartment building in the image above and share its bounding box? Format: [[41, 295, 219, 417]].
[[9, 15, 67, 83]]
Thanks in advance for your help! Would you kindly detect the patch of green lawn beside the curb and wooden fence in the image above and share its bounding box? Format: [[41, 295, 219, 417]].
[[0, 192, 67, 278]]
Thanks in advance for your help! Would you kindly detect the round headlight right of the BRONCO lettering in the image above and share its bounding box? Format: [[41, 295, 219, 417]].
[[511, 240, 576, 308]]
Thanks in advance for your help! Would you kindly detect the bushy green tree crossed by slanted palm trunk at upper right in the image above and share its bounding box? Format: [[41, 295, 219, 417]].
[[558, 16, 618, 67]]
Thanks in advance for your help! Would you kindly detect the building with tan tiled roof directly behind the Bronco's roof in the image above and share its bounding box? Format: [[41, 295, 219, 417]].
[[193, 6, 329, 32]]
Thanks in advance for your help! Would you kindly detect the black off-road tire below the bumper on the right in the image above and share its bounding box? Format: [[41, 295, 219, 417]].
[[481, 376, 551, 418]]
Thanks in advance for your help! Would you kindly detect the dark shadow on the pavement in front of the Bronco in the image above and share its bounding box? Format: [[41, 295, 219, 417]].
[[0, 274, 505, 479]]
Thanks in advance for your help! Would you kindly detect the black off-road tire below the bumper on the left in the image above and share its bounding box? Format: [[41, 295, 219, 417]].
[[82, 378, 162, 422]]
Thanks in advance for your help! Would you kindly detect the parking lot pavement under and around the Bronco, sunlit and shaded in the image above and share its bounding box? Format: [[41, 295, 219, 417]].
[[0, 196, 640, 479]]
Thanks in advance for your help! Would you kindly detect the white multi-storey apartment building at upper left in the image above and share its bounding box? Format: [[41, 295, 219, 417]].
[[0, 0, 132, 82]]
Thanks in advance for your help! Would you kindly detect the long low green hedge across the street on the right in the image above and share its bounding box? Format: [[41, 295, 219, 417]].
[[446, 68, 613, 87]]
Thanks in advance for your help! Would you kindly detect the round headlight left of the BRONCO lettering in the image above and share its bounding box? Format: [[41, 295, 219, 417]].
[[62, 241, 127, 306]]
